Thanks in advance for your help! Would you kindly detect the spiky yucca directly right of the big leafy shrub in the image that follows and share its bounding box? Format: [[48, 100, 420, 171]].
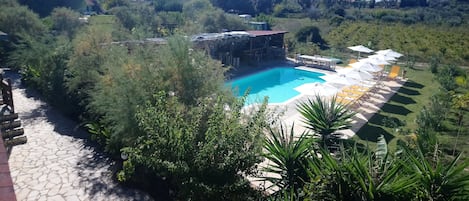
[[262, 126, 315, 192]]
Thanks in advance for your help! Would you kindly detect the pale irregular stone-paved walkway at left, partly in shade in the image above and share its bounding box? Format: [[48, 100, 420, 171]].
[[5, 71, 152, 201]]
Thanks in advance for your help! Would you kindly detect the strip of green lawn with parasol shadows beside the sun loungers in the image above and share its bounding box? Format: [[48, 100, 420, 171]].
[[354, 67, 439, 147]]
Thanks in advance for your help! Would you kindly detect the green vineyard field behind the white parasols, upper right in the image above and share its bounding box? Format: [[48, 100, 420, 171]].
[[325, 22, 469, 65]]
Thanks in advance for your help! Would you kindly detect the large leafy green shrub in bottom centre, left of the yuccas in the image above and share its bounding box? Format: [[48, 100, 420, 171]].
[[120, 92, 265, 200]]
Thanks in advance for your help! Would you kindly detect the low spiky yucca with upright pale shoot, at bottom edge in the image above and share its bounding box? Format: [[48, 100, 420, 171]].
[[342, 136, 415, 200]]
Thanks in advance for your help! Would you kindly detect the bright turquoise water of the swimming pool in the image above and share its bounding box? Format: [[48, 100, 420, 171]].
[[227, 67, 325, 104]]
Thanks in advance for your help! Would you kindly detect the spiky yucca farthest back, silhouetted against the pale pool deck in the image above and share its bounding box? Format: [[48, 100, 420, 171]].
[[297, 95, 355, 146]]
